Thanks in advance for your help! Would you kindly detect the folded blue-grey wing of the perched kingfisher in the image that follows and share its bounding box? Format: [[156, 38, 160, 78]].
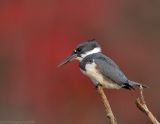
[[94, 55, 128, 85]]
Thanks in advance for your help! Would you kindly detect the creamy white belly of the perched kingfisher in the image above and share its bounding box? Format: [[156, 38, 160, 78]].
[[81, 62, 121, 89]]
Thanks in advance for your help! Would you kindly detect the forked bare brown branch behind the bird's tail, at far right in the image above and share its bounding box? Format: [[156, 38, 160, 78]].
[[136, 86, 160, 124]]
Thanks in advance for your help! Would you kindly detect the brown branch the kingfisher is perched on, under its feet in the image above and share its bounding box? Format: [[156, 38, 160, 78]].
[[97, 85, 117, 124]]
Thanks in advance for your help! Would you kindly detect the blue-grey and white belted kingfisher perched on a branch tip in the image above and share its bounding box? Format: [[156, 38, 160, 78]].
[[59, 39, 146, 89]]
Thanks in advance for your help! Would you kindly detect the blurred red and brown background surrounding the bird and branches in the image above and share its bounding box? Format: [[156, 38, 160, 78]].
[[0, 0, 160, 124]]
